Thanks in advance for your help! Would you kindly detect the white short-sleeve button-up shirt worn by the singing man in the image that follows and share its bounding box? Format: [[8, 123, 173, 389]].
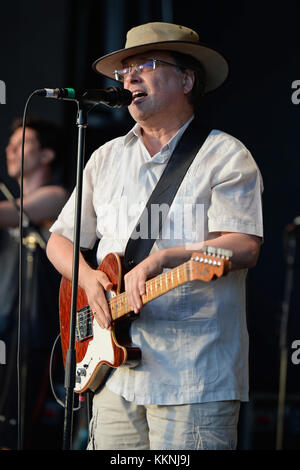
[[51, 117, 263, 404]]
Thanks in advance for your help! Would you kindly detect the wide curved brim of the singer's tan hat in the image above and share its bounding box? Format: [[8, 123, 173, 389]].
[[92, 41, 229, 93]]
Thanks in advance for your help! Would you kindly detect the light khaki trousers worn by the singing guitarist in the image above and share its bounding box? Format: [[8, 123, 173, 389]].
[[87, 387, 240, 450]]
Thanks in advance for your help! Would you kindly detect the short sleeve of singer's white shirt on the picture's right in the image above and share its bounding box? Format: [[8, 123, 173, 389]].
[[207, 139, 263, 237]]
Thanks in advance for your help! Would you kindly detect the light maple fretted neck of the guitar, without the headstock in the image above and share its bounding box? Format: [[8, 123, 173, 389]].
[[108, 260, 191, 320]]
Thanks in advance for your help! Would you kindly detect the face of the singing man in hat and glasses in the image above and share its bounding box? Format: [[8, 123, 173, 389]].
[[123, 51, 185, 122]]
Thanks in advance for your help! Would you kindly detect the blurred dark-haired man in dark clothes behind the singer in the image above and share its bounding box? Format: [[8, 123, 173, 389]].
[[0, 116, 68, 449]]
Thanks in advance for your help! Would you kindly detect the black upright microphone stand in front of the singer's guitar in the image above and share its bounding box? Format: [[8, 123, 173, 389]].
[[63, 101, 89, 450]]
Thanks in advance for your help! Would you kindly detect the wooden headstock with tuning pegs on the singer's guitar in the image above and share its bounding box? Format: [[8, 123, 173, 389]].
[[190, 246, 232, 282]]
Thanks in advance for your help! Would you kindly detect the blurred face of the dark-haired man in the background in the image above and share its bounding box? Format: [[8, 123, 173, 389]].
[[6, 127, 42, 179]]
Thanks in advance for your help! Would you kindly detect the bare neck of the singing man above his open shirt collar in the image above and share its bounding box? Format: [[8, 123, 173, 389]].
[[139, 111, 193, 157]]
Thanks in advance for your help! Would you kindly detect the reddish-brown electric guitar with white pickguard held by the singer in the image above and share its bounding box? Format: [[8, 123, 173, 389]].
[[59, 247, 232, 393]]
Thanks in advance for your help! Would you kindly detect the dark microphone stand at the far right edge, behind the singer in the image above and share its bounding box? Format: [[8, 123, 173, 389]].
[[276, 226, 297, 450]]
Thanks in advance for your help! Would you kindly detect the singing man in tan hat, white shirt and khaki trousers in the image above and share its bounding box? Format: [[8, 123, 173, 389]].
[[47, 23, 263, 450]]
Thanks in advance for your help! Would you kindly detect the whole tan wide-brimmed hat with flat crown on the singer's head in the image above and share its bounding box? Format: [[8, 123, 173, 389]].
[[93, 22, 229, 93]]
